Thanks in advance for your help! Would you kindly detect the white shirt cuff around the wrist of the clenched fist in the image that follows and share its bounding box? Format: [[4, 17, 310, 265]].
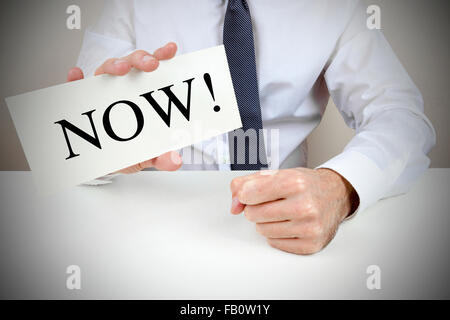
[[316, 150, 388, 219]]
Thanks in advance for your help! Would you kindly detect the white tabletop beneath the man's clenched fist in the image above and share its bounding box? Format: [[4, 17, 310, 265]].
[[0, 169, 450, 299]]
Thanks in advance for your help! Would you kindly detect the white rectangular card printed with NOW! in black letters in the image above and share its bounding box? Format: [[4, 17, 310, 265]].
[[6, 46, 242, 193]]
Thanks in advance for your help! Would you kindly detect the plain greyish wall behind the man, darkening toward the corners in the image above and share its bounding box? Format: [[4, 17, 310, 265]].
[[0, 0, 450, 170]]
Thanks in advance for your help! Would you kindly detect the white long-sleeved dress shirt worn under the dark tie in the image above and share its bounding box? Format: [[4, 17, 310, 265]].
[[78, 0, 435, 215]]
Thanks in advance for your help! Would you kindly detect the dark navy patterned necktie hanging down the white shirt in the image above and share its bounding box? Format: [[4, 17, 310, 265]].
[[223, 0, 267, 170]]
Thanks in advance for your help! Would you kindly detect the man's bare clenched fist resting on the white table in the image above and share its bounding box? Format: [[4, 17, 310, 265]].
[[231, 168, 359, 254]]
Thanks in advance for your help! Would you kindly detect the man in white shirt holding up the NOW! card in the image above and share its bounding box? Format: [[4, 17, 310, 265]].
[[68, 0, 435, 254]]
